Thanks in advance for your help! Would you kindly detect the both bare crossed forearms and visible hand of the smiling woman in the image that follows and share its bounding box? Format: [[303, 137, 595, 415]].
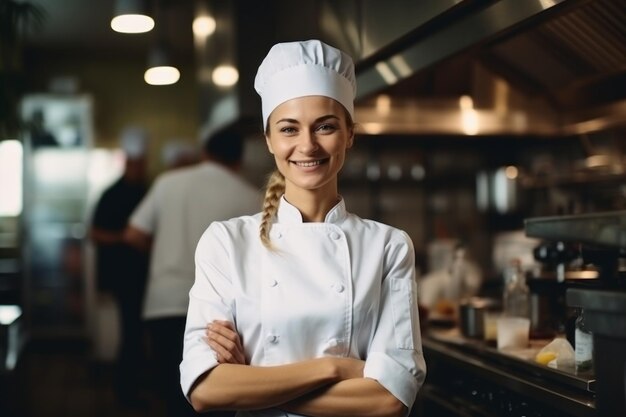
[[200, 320, 406, 417]]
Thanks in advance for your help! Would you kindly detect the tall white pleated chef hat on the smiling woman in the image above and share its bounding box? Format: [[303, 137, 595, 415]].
[[254, 40, 356, 128]]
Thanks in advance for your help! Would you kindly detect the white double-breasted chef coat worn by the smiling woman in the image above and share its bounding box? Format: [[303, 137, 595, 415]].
[[180, 197, 426, 416]]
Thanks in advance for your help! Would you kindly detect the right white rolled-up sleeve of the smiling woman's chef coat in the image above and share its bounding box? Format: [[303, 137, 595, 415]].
[[364, 231, 426, 410]]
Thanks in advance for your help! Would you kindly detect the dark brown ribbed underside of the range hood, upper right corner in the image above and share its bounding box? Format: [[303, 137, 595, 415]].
[[479, 0, 626, 110]]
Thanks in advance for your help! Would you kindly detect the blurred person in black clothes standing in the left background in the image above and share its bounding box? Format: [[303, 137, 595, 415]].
[[90, 127, 148, 407]]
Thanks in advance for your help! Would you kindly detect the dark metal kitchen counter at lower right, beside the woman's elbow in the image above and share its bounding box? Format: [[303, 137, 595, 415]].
[[416, 332, 598, 417]]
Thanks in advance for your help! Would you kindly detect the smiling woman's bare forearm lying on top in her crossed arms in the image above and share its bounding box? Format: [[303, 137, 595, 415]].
[[189, 358, 364, 412]]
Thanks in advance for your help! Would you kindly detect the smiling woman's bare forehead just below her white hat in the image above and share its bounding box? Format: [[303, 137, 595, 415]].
[[270, 96, 345, 122]]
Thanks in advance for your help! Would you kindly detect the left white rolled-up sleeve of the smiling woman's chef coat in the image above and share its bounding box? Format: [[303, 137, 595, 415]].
[[180, 223, 234, 399]]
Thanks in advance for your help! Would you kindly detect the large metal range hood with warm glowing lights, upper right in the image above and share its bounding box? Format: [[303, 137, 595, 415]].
[[344, 0, 626, 136]]
